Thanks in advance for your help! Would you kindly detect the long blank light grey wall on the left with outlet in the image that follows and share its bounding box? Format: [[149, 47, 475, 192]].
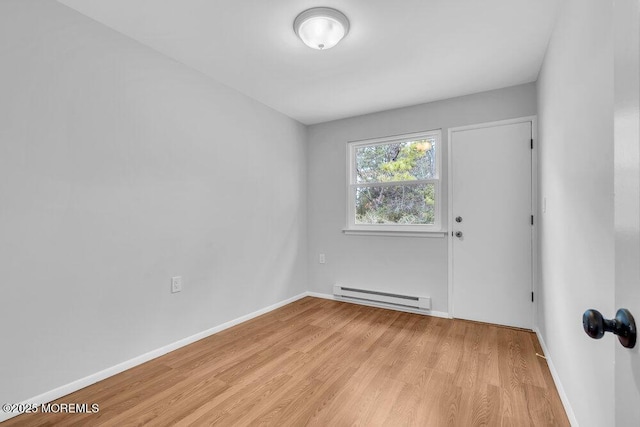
[[0, 0, 307, 403]]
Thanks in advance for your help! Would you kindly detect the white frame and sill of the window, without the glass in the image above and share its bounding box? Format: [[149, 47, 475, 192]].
[[343, 129, 445, 237]]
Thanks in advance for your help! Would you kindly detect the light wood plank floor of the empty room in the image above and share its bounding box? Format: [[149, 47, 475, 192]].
[[3, 298, 569, 427]]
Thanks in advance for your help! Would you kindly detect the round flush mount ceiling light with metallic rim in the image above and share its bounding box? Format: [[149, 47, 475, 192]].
[[293, 7, 349, 50]]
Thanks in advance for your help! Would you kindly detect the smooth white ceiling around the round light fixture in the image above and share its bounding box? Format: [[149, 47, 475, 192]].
[[59, 0, 561, 124]]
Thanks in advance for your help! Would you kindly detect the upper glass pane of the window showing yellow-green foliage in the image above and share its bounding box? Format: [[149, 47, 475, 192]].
[[356, 138, 436, 183]]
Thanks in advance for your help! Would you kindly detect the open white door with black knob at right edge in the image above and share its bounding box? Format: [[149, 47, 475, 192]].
[[608, 0, 640, 427]]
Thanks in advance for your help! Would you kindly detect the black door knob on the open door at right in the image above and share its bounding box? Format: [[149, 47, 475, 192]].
[[582, 308, 637, 348]]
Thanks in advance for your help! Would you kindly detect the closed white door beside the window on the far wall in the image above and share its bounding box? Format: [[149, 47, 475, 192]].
[[449, 119, 533, 329]]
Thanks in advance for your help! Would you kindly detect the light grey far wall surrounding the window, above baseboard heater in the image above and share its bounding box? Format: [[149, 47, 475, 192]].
[[307, 83, 536, 312]]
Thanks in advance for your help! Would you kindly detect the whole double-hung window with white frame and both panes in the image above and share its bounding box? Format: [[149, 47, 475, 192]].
[[345, 130, 441, 232]]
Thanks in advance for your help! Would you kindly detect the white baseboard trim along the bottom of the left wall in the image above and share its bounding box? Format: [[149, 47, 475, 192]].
[[0, 292, 308, 423]]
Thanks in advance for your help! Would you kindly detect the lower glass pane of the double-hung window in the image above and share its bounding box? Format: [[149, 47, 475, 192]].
[[355, 184, 435, 225]]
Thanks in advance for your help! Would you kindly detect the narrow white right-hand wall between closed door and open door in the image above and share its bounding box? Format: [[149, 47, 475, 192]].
[[538, 0, 615, 427]]
